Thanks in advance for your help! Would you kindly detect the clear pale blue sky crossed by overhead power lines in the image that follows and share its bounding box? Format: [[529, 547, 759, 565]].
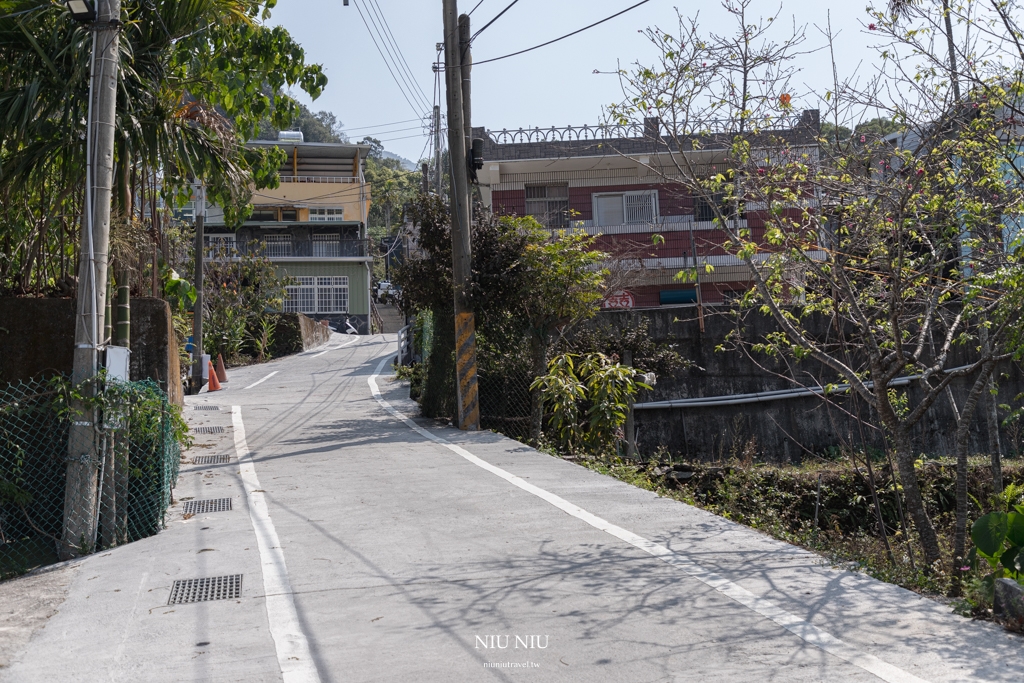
[[271, 0, 879, 161]]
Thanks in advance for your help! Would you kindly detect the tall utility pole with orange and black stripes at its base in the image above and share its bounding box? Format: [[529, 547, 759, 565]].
[[443, 0, 480, 431]]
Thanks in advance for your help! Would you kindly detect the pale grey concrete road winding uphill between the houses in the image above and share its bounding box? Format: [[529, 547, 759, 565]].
[[0, 336, 1024, 683]]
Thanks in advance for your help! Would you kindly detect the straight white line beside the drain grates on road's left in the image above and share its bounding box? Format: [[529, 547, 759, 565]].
[[231, 405, 321, 683]]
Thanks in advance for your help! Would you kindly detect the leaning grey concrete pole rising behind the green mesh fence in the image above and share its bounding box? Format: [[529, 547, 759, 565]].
[[59, 0, 121, 559]]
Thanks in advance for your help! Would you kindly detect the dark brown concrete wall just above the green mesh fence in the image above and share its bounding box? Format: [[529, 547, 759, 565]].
[[0, 298, 182, 404]]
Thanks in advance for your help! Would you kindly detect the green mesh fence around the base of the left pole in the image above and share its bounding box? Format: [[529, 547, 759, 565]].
[[0, 378, 180, 579]]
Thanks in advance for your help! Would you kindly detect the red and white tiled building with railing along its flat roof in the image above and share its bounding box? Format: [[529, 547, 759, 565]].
[[474, 110, 819, 308]]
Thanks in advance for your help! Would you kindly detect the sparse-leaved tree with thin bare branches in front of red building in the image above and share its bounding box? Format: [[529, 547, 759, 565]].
[[609, 0, 1024, 565]]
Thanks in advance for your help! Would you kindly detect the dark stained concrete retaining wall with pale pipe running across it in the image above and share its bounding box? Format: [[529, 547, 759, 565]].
[[592, 306, 1024, 462]]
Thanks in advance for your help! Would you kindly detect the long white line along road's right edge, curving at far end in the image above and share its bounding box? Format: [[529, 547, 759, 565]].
[[367, 355, 927, 683]]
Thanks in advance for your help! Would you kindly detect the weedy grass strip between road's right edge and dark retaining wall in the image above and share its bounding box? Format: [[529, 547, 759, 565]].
[[577, 457, 1024, 602]]
